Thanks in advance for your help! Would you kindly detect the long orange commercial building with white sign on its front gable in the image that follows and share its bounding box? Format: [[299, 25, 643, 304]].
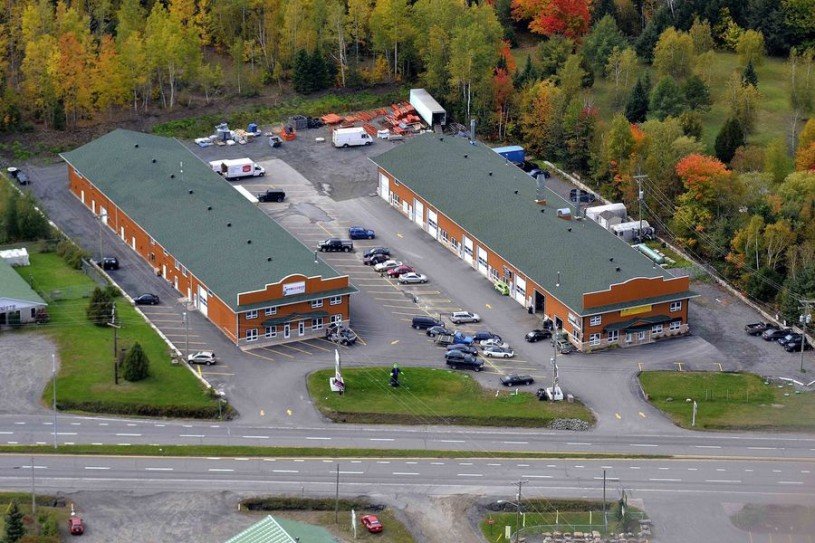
[[61, 130, 356, 347]]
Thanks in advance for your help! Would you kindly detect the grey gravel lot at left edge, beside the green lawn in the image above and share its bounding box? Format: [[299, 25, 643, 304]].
[[0, 330, 59, 414]]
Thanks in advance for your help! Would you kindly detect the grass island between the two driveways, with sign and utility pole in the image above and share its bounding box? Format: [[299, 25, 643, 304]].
[[308, 366, 594, 427]]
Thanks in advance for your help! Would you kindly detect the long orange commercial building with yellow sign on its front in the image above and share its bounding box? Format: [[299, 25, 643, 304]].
[[372, 134, 694, 351]]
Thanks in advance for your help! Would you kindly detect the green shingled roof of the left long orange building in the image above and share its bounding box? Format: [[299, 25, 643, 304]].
[[61, 130, 350, 310]]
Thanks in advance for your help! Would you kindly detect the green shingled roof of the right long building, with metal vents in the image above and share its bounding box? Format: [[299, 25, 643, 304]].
[[372, 134, 688, 315]]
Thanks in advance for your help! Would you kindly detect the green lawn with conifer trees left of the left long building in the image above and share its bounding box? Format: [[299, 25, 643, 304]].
[[19, 252, 218, 417]]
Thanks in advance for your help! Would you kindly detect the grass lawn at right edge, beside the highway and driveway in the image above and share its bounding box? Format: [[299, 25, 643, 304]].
[[640, 371, 815, 431]]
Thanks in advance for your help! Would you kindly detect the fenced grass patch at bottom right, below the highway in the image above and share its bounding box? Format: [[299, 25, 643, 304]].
[[480, 499, 643, 542]]
